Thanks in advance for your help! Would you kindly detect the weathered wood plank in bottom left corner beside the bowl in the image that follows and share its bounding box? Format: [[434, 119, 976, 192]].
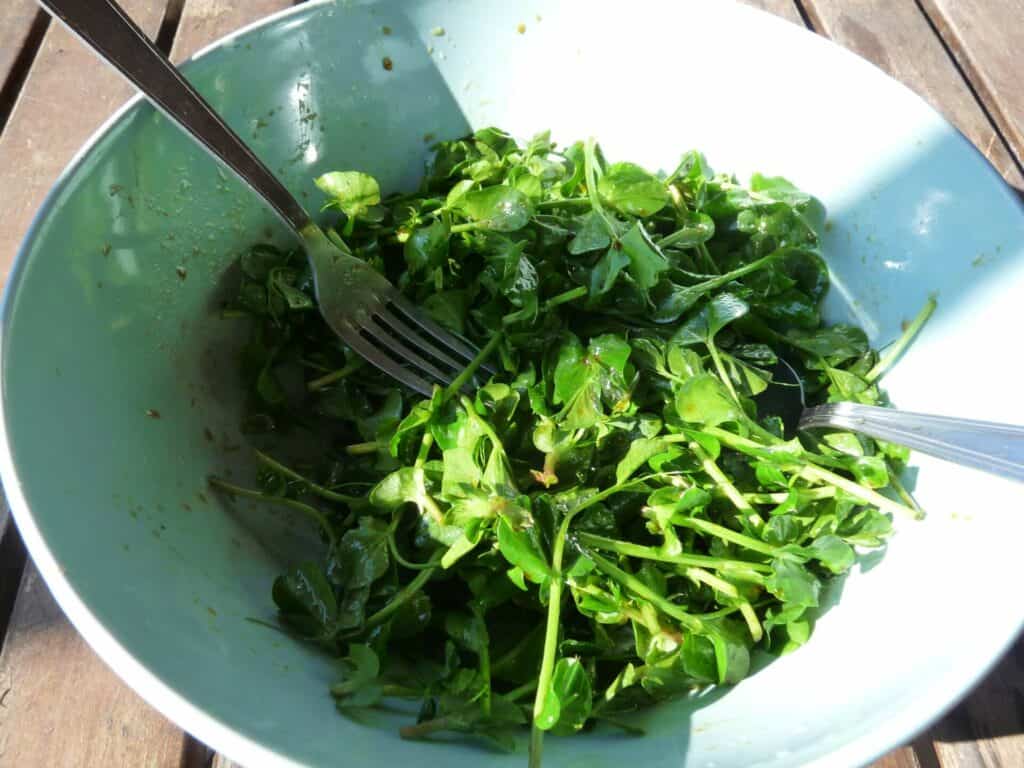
[[0, 564, 185, 768]]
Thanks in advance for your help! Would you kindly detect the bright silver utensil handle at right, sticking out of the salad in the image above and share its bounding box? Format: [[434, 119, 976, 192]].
[[800, 402, 1024, 481]]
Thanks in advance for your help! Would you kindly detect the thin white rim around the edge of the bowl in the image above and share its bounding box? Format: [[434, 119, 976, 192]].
[[0, 0, 1024, 768]]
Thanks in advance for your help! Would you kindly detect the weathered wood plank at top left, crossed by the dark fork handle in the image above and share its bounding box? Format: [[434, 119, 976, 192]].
[[0, 0, 165, 283]]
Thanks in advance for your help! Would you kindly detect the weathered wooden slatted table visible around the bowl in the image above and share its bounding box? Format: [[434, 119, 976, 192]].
[[0, 0, 1024, 768]]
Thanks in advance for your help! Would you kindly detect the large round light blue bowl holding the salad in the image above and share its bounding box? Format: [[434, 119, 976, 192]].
[[0, 0, 1024, 768]]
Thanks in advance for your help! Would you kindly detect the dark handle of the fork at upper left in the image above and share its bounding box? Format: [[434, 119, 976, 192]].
[[39, 0, 310, 232]]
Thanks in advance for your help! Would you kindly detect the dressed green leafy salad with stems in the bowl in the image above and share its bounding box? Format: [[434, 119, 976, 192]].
[[211, 129, 933, 766]]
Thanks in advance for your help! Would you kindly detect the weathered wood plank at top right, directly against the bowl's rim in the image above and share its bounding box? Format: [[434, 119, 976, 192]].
[[804, 0, 1024, 188]]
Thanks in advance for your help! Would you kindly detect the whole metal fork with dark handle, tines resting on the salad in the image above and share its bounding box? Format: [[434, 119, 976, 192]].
[[45, 0, 494, 396]]
